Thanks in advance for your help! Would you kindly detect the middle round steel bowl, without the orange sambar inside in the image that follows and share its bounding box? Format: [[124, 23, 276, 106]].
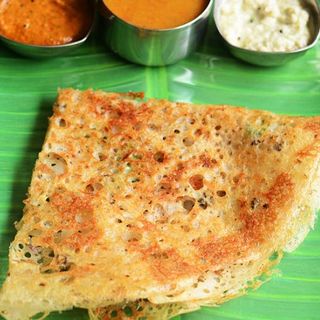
[[100, 0, 213, 66]]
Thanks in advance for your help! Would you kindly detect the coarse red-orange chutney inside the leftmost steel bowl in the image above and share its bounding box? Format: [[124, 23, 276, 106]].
[[0, 0, 94, 45]]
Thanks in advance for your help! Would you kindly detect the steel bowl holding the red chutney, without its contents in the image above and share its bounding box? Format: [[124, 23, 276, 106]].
[[0, 1, 96, 58]]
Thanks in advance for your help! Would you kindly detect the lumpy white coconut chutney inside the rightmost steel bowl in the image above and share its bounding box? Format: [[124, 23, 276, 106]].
[[216, 0, 310, 51]]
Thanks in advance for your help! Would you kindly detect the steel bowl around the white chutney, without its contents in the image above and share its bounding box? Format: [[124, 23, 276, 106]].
[[214, 0, 320, 67]]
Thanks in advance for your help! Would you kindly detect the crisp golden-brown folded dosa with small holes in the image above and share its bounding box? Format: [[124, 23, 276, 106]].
[[0, 89, 320, 319]]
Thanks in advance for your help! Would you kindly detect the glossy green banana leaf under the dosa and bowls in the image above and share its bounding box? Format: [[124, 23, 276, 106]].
[[0, 11, 320, 320]]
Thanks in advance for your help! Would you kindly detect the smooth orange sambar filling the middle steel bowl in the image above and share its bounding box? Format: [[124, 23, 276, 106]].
[[104, 0, 209, 29]]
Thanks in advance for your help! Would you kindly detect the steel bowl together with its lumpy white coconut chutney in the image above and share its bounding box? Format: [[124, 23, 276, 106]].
[[214, 0, 320, 66]]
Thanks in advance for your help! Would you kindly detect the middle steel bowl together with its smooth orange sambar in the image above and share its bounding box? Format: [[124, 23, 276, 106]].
[[100, 0, 213, 66]]
